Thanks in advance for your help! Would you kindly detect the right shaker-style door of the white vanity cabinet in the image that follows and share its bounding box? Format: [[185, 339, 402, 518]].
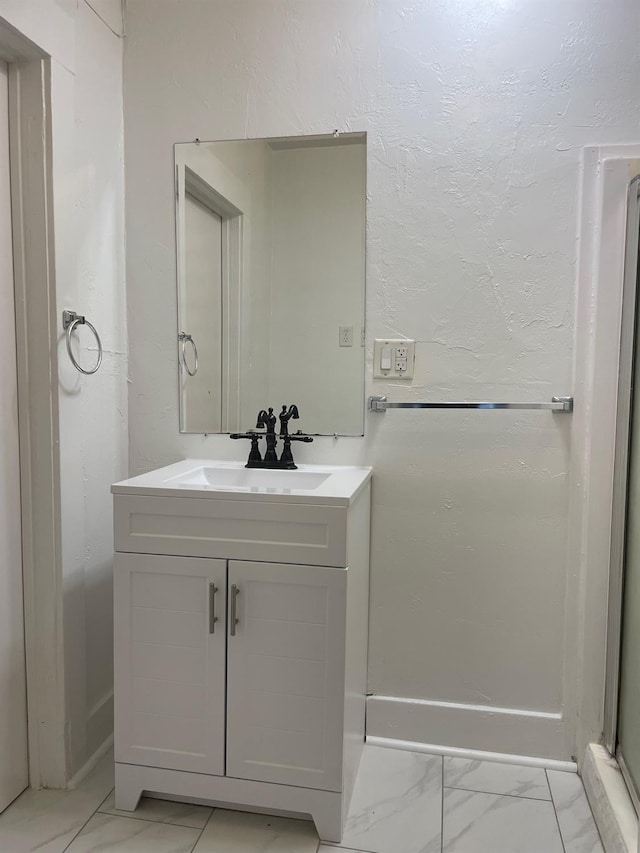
[[227, 561, 347, 791]]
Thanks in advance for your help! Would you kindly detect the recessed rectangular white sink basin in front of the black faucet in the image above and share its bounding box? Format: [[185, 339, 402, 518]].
[[166, 465, 331, 491]]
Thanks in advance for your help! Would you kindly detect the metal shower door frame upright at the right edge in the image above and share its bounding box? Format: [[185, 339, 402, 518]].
[[604, 175, 640, 755]]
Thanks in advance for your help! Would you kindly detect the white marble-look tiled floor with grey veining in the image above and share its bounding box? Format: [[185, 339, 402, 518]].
[[0, 746, 603, 853]]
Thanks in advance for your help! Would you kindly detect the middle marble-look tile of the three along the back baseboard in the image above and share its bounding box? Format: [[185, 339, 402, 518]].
[[444, 758, 551, 800]]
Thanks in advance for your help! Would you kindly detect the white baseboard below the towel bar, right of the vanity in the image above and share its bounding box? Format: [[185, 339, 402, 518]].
[[367, 695, 572, 766]]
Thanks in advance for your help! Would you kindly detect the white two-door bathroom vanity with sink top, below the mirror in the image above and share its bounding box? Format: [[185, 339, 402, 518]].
[[112, 460, 371, 842]]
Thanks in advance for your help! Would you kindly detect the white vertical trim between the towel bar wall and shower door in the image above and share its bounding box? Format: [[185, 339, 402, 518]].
[[564, 145, 640, 762]]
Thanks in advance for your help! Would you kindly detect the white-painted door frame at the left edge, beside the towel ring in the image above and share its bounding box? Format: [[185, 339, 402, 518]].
[[0, 19, 67, 788]]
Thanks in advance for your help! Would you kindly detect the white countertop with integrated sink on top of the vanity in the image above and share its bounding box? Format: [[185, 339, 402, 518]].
[[111, 459, 371, 506]]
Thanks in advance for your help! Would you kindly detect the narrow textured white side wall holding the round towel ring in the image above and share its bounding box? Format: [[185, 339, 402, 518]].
[[0, 0, 128, 777]]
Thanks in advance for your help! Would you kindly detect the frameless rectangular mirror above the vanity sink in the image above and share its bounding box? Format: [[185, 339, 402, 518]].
[[175, 133, 366, 435]]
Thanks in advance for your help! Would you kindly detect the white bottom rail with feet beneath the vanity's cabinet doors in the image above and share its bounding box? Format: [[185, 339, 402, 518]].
[[115, 762, 344, 844]]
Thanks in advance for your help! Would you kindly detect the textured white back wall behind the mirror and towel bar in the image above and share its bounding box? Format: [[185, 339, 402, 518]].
[[125, 0, 640, 757]]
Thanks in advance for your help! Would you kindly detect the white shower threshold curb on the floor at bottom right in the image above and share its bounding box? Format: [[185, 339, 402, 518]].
[[581, 743, 638, 853]]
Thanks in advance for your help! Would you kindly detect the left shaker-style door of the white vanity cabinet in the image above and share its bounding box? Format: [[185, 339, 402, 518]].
[[114, 554, 226, 775]]
